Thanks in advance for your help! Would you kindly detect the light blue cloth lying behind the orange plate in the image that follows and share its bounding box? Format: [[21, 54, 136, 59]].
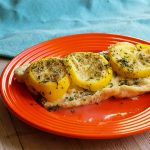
[[0, 0, 150, 58]]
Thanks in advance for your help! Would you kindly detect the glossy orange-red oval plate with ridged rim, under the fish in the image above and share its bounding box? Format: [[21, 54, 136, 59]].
[[1, 33, 150, 139]]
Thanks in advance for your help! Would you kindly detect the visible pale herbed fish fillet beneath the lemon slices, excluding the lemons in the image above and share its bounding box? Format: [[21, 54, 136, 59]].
[[14, 61, 150, 108]]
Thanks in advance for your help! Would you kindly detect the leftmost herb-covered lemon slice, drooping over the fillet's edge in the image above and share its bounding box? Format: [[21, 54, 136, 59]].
[[24, 58, 70, 102]]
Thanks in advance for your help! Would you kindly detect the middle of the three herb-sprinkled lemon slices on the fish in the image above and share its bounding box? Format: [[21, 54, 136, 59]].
[[64, 52, 112, 91]]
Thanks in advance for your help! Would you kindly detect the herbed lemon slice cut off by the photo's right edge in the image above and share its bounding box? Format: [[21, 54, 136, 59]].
[[109, 42, 150, 78]]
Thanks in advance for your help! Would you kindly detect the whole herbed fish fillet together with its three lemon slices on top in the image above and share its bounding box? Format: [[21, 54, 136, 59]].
[[14, 42, 150, 109]]
